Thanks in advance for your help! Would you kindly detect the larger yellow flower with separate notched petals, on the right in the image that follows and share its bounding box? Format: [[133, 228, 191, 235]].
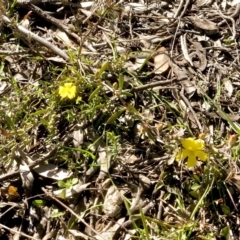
[[176, 138, 208, 168]]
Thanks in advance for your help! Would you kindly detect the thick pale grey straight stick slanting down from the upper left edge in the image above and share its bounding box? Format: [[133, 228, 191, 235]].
[[2, 15, 69, 60]]
